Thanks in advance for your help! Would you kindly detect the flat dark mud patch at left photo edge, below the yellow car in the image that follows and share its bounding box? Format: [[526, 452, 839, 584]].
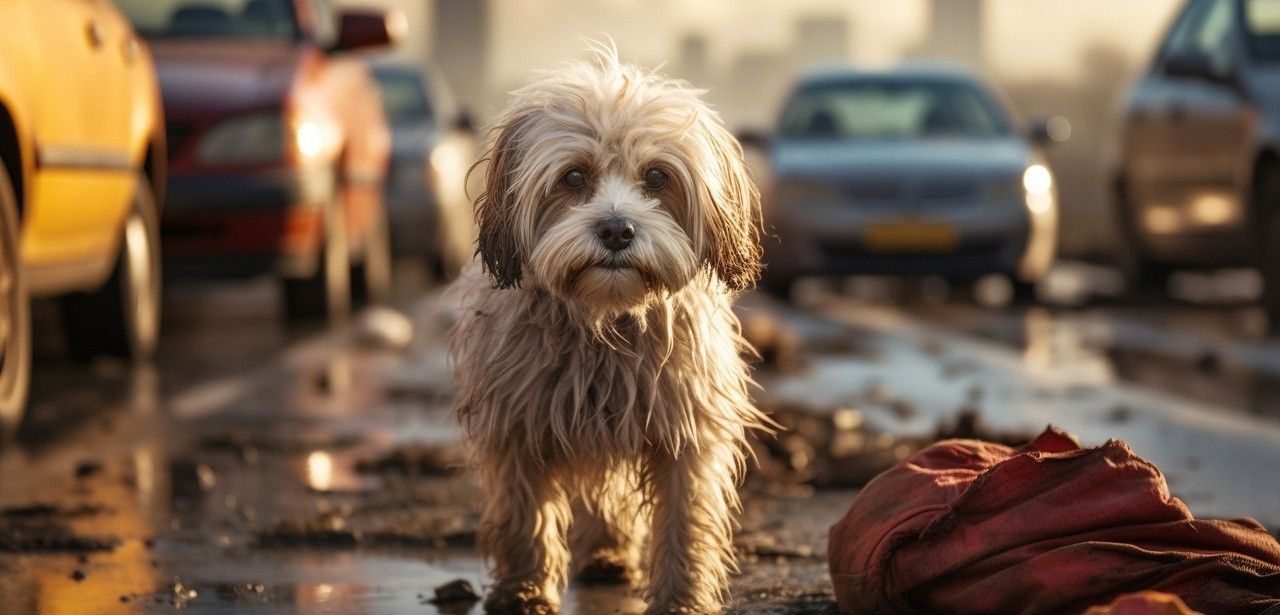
[[0, 504, 120, 554]]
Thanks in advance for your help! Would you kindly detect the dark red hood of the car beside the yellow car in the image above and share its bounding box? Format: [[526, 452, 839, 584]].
[[151, 40, 310, 120]]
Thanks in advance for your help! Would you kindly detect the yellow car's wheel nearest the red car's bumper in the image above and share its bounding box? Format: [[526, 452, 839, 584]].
[[61, 176, 163, 363]]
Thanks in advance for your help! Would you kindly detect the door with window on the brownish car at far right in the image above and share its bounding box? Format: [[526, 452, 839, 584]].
[[1140, 0, 1256, 233]]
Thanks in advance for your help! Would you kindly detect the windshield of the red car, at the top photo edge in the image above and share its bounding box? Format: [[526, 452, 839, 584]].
[[116, 0, 298, 40]]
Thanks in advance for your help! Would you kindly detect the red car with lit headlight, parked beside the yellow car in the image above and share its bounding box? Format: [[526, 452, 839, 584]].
[[118, 0, 404, 319]]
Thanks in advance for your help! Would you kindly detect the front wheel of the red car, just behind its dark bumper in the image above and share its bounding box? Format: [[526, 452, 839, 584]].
[[282, 197, 351, 322]]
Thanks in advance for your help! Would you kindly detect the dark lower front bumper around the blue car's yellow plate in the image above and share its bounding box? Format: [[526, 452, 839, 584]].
[[765, 202, 1039, 279]]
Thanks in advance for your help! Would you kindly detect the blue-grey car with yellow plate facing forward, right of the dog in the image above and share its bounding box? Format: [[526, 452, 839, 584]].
[[762, 65, 1057, 296]]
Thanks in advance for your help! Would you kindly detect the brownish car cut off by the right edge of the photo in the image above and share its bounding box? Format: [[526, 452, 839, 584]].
[[1114, 0, 1280, 320]]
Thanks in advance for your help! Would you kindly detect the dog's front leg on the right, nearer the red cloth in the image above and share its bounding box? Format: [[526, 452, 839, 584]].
[[645, 442, 737, 614]]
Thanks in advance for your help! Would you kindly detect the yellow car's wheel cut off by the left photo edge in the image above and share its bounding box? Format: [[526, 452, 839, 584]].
[[0, 160, 31, 442]]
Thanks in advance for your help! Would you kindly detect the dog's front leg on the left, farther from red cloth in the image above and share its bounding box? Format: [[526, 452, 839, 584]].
[[477, 451, 571, 615]]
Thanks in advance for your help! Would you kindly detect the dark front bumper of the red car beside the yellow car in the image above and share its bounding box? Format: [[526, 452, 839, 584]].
[[161, 169, 335, 277]]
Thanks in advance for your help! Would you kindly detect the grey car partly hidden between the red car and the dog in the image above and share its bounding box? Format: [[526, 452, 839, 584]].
[[374, 64, 477, 279]]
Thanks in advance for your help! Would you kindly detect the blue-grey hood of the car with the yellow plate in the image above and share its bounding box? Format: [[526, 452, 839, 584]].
[[773, 137, 1032, 181]]
